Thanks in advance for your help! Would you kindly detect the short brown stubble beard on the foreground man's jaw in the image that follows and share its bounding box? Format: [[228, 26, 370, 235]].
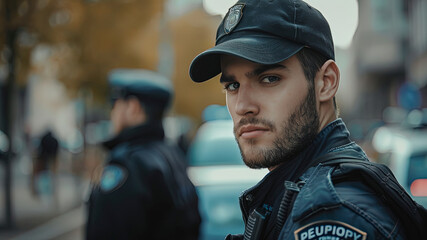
[[237, 84, 319, 169]]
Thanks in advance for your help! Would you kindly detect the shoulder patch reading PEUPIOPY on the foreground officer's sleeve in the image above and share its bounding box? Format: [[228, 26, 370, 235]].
[[294, 220, 367, 240]]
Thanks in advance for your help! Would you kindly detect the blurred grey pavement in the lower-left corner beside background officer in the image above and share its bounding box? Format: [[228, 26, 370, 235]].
[[0, 158, 88, 240]]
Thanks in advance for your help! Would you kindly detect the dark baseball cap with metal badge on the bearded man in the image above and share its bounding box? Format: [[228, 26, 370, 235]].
[[190, 0, 335, 82]]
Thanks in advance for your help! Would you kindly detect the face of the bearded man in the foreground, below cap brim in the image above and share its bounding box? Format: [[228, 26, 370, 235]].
[[221, 55, 319, 169]]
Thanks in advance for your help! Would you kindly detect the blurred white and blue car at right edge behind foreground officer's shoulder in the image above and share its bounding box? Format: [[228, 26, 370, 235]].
[[373, 109, 427, 208]]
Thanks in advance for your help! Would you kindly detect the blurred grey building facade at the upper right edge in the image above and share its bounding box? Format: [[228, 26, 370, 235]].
[[349, 0, 427, 120]]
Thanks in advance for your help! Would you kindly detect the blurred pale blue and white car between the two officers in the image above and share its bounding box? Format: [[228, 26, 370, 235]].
[[188, 120, 268, 240]]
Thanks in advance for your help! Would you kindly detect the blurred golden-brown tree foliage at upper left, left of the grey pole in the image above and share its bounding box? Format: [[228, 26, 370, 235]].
[[0, 0, 163, 100]]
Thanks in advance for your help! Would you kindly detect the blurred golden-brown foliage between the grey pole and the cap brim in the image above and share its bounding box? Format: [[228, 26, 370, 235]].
[[170, 9, 225, 124]]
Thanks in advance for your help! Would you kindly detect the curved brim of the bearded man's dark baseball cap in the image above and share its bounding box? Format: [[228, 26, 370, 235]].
[[190, 35, 304, 82]]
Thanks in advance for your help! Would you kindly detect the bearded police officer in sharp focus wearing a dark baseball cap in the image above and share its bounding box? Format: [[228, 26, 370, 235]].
[[190, 0, 427, 240]]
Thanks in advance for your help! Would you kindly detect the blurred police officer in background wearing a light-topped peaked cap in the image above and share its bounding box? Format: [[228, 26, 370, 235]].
[[86, 69, 201, 239]]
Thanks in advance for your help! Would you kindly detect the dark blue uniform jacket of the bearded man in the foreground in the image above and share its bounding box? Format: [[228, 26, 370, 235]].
[[227, 119, 406, 240]]
